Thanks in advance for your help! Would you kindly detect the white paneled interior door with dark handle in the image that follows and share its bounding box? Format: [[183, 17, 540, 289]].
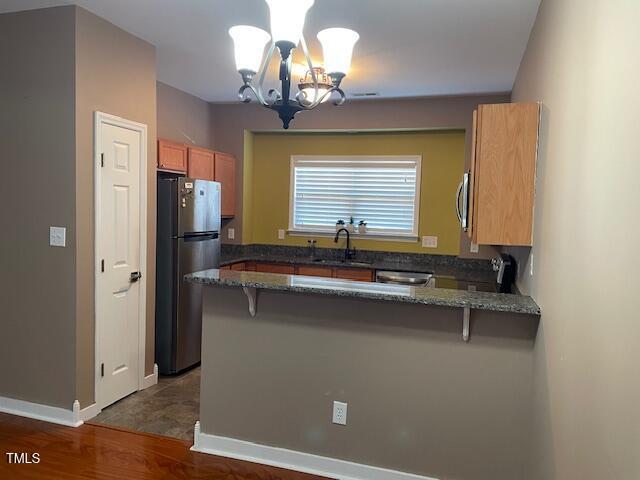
[[96, 116, 145, 408]]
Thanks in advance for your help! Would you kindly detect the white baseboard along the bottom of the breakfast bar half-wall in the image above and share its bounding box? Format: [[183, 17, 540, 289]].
[[191, 422, 436, 480]]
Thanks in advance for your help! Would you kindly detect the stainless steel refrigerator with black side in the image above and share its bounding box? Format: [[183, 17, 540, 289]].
[[156, 178, 220, 374]]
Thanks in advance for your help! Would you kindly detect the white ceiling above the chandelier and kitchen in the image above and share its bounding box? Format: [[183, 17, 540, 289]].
[[0, 0, 540, 102]]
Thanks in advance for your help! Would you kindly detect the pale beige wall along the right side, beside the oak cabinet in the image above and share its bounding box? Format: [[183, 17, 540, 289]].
[[513, 0, 640, 480]]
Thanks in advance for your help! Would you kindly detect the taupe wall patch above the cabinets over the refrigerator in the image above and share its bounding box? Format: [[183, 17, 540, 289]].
[[157, 82, 214, 148]]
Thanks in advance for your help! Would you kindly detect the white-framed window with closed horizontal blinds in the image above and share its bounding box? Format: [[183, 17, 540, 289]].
[[289, 156, 422, 238]]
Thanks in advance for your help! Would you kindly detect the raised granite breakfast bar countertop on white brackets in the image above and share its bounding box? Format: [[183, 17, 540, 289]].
[[185, 269, 540, 315]]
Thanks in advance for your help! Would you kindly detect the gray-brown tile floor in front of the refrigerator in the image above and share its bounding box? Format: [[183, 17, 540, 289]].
[[91, 367, 200, 441]]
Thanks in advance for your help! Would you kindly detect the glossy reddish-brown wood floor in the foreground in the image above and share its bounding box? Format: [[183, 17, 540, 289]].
[[0, 413, 326, 480]]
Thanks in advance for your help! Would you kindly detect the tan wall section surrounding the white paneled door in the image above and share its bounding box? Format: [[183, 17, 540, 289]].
[[75, 8, 157, 407]]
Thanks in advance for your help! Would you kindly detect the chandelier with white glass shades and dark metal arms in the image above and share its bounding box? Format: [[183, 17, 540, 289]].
[[229, 0, 359, 129]]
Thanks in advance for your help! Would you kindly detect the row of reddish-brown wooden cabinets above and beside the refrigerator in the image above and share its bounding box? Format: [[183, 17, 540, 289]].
[[158, 140, 236, 218]]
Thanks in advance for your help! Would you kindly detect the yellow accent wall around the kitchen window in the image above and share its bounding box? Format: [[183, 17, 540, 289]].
[[243, 130, 465, 255]]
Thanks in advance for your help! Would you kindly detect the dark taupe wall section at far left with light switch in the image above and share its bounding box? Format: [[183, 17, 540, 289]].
[[0, 7, 77, 409]]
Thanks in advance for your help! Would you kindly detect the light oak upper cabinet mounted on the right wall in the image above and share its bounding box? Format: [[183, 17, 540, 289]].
[[469, 103, 540, 246]]
